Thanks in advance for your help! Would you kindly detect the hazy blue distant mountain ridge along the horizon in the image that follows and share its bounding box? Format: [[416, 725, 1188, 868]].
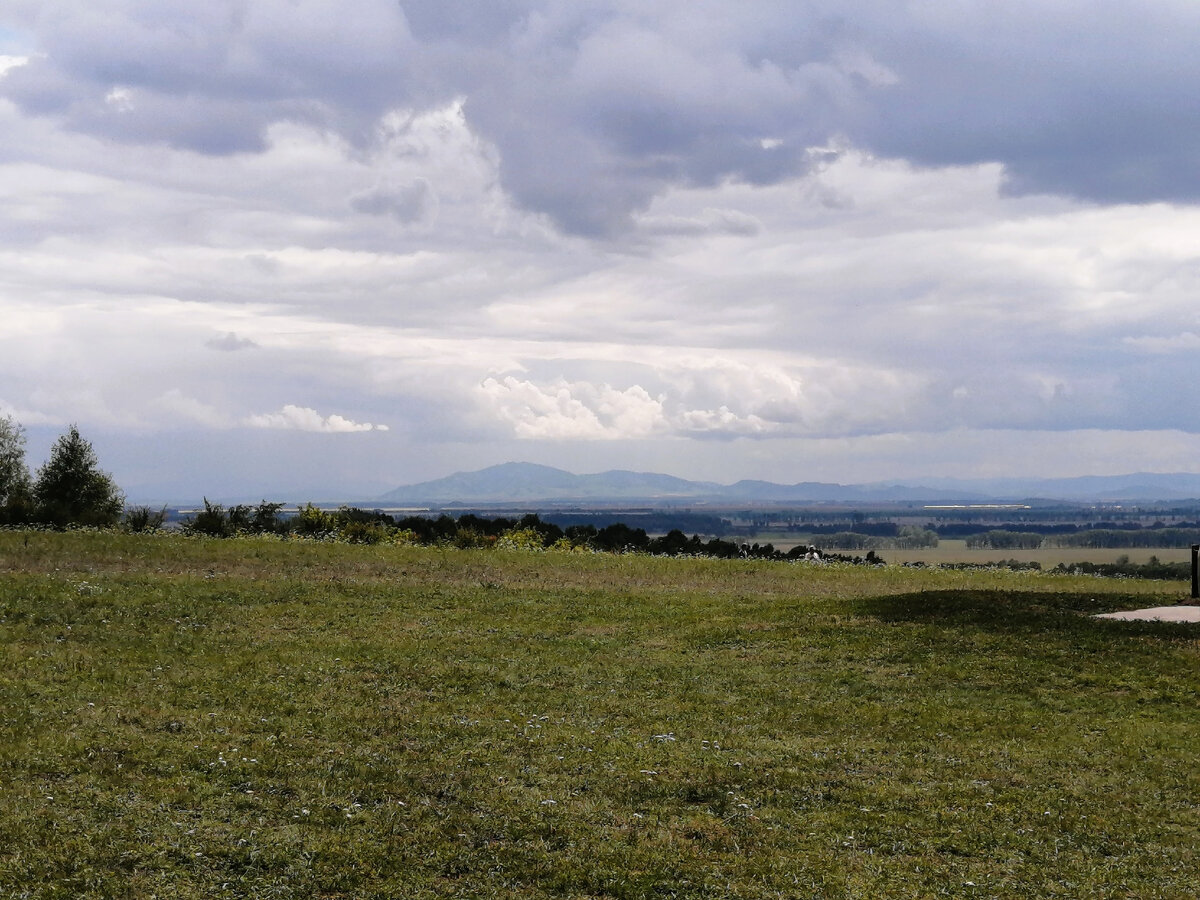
[[380, 462, 1200, 505]]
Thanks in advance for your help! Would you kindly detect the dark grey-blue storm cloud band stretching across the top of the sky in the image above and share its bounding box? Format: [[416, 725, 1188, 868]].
[[9, 0, 1200, 234]]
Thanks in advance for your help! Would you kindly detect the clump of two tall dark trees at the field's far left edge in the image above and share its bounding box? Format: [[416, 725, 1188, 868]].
[[0, 416, 125, 528]]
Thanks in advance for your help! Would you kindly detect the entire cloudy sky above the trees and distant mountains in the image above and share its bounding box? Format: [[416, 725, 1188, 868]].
[[0, 0, 1200, 503]]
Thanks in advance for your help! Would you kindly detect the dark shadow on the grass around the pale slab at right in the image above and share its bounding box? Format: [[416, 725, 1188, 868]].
[[852, 590, 1200, 637]]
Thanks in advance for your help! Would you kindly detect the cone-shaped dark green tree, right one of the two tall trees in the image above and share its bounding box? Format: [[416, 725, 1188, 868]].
[[34, 425, 125, 528]]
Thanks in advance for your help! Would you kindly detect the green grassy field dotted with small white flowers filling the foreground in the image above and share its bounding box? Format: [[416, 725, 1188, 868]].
[[0, 533, 1200, 899]]
